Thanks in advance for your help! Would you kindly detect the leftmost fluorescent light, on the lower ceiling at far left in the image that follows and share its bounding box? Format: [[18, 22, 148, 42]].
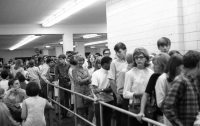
[[10, 35, 40, 50]]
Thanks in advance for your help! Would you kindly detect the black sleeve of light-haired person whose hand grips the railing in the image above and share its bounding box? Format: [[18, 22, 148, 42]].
[[145, 74, 158, 95]]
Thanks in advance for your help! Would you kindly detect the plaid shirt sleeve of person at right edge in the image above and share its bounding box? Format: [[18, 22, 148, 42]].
[[162, 82, 185, 126]]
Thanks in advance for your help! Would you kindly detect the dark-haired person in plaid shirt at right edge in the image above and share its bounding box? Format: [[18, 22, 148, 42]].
[[162, 50, 200, 126]]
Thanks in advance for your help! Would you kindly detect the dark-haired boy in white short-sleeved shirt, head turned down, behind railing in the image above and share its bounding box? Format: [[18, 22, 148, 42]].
[[91, 56, 113, 126]]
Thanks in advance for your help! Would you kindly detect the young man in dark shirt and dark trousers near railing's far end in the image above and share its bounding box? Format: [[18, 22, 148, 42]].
[[54, 54, 71, 118]]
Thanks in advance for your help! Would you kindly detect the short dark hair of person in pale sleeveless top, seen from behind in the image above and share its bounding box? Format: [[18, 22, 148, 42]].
[[26, 82, 40, 96]]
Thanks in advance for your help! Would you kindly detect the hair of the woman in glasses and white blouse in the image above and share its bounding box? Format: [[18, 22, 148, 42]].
[[133, 47, 150, 67]]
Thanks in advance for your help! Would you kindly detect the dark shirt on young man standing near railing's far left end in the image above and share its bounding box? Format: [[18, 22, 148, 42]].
[[55, 63, 70, 81]]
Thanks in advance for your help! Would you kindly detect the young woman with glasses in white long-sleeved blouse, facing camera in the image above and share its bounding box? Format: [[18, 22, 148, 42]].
[[123, 47, 154, 126]]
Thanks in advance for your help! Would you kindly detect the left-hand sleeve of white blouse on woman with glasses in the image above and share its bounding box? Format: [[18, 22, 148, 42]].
[[123, 72, 134, 99]]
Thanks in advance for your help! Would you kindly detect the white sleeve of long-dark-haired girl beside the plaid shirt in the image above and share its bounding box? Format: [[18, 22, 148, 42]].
[[155, 75, 168, 108]]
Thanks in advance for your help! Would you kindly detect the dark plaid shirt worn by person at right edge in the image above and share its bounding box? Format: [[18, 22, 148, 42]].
[[163, 75, 199, 126]]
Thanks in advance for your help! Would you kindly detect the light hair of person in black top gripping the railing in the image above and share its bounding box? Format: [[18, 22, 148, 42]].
[[152, 53, 170, 71]]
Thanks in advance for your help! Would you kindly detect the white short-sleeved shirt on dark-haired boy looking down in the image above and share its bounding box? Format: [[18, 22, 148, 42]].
[[92, 68, 110, 89]]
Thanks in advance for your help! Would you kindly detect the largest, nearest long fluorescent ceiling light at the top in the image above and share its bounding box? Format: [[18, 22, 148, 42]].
[[42, 0, 97, 27]]
